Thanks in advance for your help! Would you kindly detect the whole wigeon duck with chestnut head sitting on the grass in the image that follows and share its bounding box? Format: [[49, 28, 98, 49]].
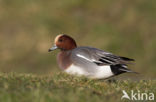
[[49, 34, 134, 79]]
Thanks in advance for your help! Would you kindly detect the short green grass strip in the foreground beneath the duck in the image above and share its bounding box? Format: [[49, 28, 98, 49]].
[[0, 73, 156, 102]]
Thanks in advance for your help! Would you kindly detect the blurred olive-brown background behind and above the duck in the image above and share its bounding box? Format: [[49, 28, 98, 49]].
[[0, 0, 156, 78]]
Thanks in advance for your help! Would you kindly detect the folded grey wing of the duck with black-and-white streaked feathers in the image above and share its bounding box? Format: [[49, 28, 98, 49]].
[[71, 47, 134, 66]]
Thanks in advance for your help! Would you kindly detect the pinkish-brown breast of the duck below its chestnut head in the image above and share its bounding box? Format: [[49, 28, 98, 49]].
[[57, 51, 72, 70]]
